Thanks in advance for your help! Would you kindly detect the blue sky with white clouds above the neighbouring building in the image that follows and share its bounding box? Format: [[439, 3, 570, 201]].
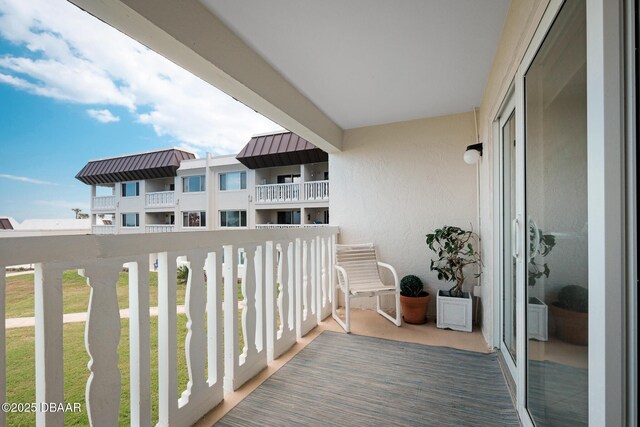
[[0, 0, 282, 221]]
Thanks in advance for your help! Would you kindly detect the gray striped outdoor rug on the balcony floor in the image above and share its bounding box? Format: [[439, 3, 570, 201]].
[[217, 332, 519, 427]]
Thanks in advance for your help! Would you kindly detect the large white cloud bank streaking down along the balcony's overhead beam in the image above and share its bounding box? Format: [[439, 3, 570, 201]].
[[0, 0, 281, 154]]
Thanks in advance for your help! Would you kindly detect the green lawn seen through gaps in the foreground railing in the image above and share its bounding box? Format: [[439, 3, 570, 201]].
[[6, 270, 255, 426]]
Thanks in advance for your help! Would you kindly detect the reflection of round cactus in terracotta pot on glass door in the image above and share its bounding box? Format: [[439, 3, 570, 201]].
[[551, 285, 589, 345]]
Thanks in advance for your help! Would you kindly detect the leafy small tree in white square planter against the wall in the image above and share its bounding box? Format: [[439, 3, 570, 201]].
[[426, 225, 481, 332]]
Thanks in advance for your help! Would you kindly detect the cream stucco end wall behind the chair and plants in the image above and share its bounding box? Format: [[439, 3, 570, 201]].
[[329, 113, 476, 314]]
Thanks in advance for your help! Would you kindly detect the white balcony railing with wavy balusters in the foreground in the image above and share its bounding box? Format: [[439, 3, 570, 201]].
[[0, 227, 338, 426]]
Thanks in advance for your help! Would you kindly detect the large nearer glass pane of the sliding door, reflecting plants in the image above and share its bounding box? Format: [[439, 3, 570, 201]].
[[523, 1, 589, 426]]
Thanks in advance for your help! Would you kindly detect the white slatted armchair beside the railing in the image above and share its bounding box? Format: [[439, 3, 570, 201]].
[[332, 243, 402, 333]]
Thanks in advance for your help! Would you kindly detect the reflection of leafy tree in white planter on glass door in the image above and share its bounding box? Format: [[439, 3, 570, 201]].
[[527, 219, 556, 341]]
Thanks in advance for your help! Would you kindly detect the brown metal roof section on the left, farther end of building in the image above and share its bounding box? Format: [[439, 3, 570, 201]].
[[76, 148, 196, 185]]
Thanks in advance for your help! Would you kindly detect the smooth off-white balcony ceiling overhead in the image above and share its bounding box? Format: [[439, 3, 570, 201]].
[[201, 0, 510, 129]]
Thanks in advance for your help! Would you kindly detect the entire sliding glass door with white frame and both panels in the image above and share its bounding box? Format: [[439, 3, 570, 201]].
[[495, 1, 589, 426]]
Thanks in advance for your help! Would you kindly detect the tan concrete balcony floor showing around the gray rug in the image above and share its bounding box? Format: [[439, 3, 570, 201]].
[[195, 309, 491, 427]]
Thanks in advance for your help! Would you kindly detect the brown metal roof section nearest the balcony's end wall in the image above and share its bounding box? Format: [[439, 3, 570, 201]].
[[236, 132, 329, 169]]
